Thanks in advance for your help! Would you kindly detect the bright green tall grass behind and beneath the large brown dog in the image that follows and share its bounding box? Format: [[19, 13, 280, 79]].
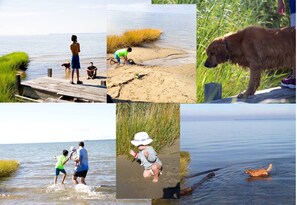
[[152, 0, 291, 103]]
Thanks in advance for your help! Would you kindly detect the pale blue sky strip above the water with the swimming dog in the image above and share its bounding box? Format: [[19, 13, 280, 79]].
[[181, 104, 296, 120]]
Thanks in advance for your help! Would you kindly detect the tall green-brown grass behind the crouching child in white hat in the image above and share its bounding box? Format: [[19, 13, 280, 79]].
[[116, 103, 180, 155]]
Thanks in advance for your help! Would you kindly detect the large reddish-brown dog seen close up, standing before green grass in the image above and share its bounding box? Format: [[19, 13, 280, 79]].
[[204, 26, 296, 98]]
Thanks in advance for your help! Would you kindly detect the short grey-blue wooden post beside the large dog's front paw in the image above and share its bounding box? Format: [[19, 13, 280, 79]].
[[204, 83, 222, 102]]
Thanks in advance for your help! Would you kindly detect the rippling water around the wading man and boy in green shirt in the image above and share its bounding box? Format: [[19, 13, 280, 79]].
[[0, 140, 148, 204]]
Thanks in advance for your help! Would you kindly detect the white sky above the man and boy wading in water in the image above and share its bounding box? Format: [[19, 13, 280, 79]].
[[0, 103, 116, 144]]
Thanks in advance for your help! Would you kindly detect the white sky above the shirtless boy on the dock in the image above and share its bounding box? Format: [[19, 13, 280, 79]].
[[0, 0, 112, 35]]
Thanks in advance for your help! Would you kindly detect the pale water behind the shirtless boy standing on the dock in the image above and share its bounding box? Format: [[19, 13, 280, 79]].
[[0, 33, 106, 79]]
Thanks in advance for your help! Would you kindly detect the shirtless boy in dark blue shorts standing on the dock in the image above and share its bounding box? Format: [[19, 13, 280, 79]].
[[70, 35, 83, 84]]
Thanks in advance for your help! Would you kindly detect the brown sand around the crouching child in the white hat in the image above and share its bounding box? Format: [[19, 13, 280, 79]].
[[116, 140, 180, 199]]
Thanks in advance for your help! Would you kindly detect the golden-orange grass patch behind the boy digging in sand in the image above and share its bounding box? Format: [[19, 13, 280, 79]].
[[107, 29, 162, 53]]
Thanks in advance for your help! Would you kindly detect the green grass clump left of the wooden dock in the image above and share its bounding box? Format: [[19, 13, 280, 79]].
[[0, 52, 29, 102]]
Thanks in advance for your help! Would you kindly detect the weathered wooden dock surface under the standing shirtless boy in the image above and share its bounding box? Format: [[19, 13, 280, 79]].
[[21, 77, 107, 102]]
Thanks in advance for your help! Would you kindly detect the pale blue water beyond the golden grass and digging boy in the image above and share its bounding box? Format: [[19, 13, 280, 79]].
[[107, 10, 196, 63]]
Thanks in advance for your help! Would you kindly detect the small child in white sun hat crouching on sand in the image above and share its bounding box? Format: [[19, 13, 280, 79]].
[[130, 132, 162, 182]]
